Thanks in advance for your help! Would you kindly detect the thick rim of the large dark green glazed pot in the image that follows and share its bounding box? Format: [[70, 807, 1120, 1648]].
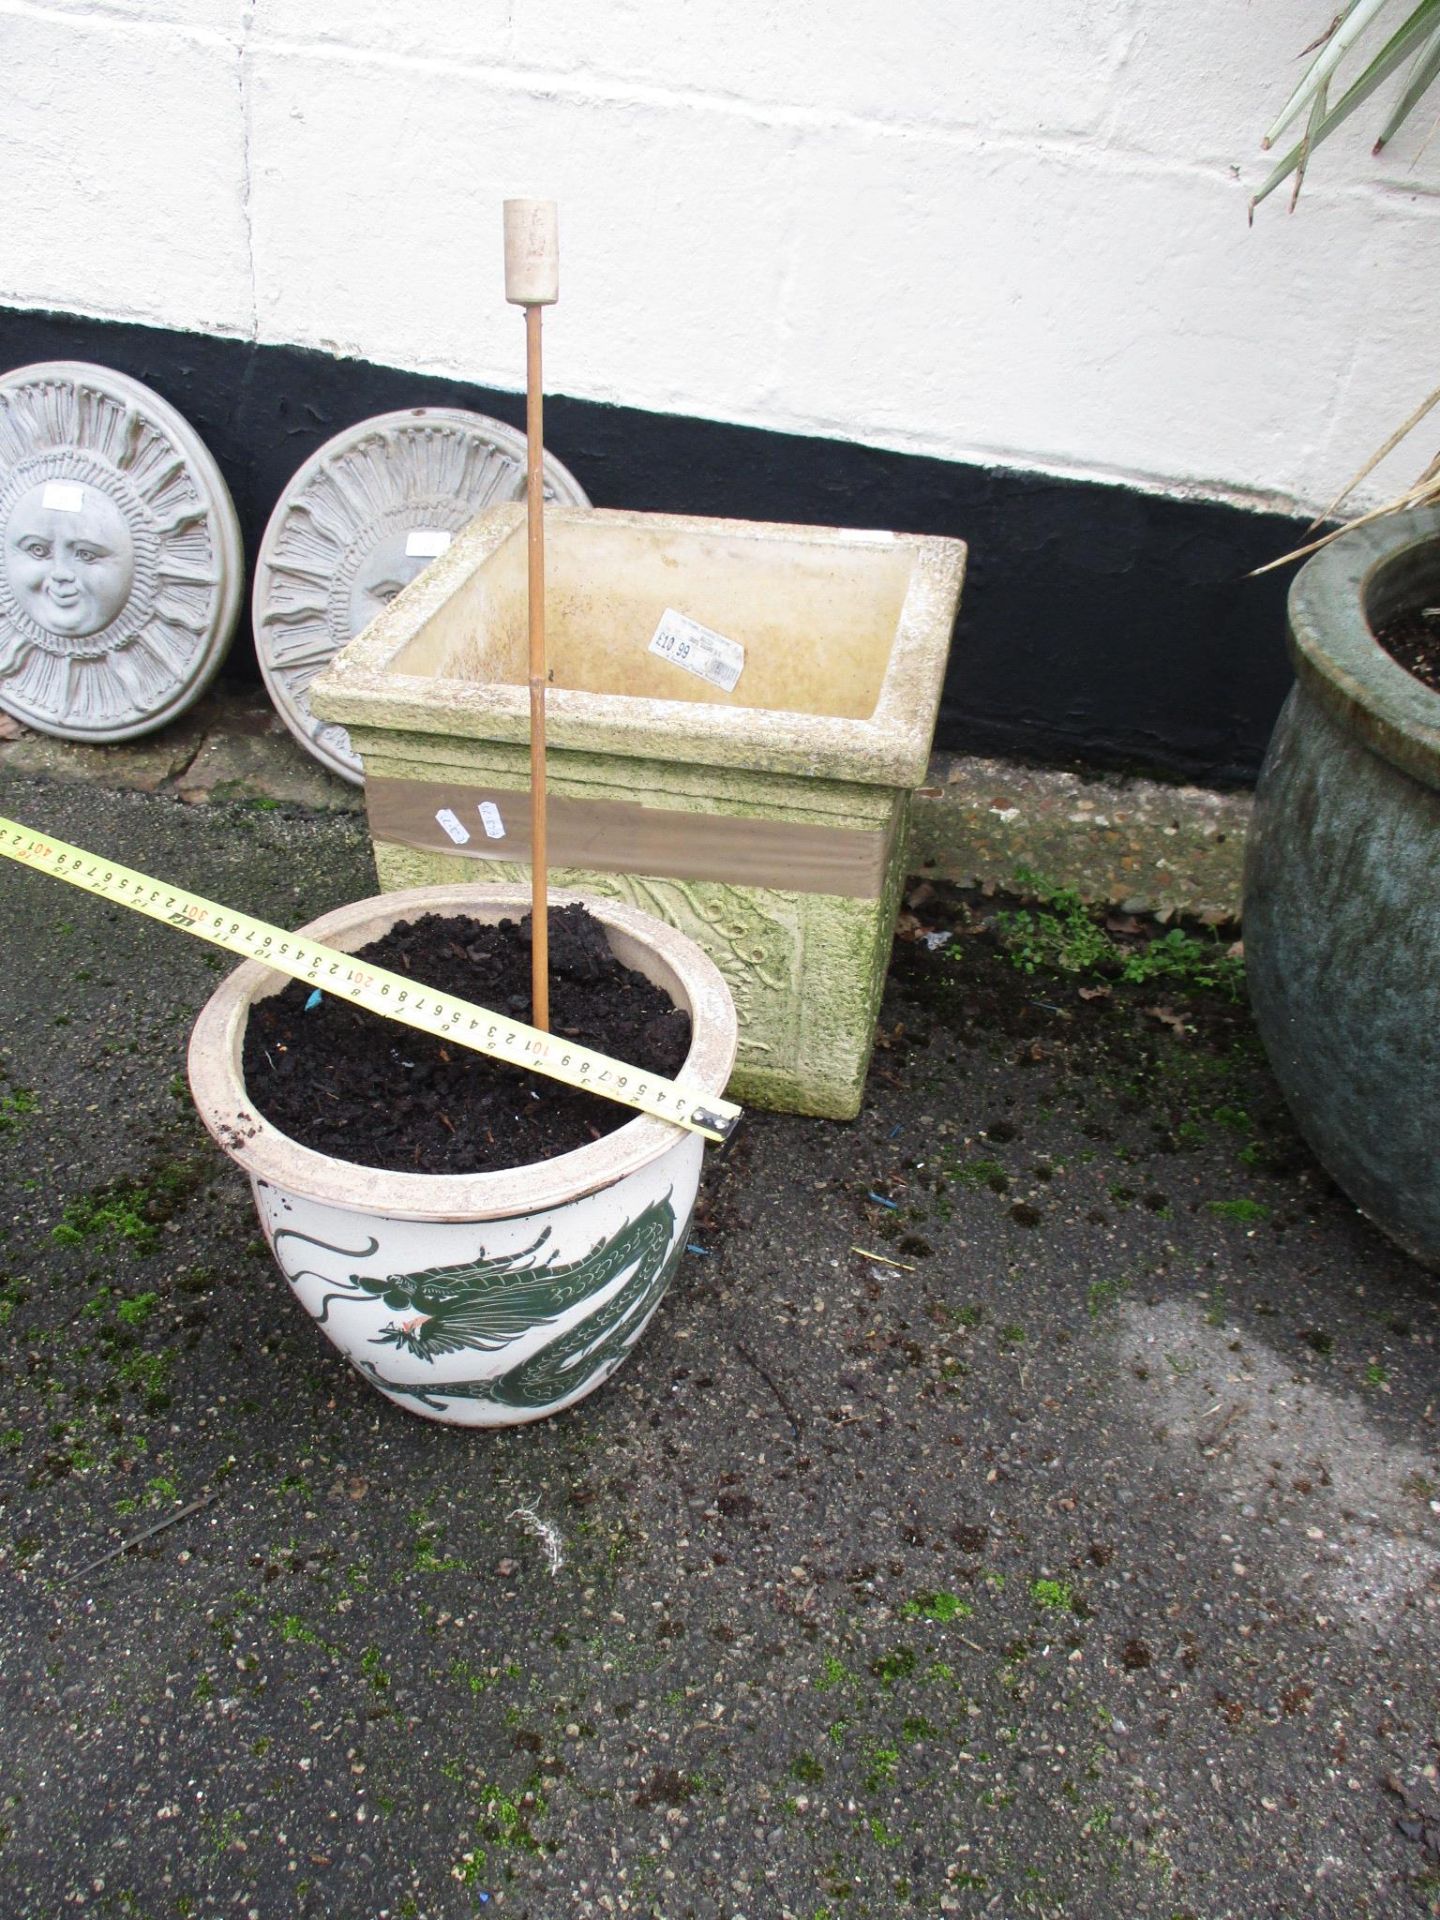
[[1288, 507, 1440, 787]]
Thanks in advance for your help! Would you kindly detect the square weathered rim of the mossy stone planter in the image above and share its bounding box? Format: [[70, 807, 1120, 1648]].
[[311, 503, 966, 787]]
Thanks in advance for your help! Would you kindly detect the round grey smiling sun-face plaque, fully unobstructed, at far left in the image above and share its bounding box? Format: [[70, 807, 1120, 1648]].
[[0, 361, 244, 741]]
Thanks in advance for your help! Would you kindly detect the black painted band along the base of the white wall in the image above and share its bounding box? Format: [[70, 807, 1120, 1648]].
[[0, 307, 1320, 785]]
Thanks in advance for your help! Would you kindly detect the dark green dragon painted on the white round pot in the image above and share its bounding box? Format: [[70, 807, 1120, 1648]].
[[275, 1194, 676, 1407]]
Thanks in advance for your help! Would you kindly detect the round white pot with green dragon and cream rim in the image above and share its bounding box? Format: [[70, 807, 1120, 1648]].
[[190, 887, 735, 1427]]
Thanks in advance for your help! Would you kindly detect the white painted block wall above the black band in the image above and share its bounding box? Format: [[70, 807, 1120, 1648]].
[[0, 0, 1440, 505]]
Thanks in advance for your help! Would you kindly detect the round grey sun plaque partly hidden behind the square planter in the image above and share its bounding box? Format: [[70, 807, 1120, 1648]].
[[252, 407, 589, 783]]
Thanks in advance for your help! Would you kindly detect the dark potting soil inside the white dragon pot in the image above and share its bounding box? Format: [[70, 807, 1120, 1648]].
[[244, 906, 689, 1173]]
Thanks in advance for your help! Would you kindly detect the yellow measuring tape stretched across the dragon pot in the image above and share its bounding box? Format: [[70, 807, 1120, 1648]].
[[0, 818, 741, 1140]]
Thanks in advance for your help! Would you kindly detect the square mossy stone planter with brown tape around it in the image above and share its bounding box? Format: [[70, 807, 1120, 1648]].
[[311, 507, 964, 1119]]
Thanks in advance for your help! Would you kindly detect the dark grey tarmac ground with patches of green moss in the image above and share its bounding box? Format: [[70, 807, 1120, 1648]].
[[0, 770, 1440, 1920]]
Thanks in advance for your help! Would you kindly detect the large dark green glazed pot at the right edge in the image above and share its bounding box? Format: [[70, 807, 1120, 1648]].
[[1244, 509, 1440, 1267]]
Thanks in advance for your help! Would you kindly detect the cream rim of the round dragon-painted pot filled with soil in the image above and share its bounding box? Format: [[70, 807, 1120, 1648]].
[[188, 885, 735, 1221]]
